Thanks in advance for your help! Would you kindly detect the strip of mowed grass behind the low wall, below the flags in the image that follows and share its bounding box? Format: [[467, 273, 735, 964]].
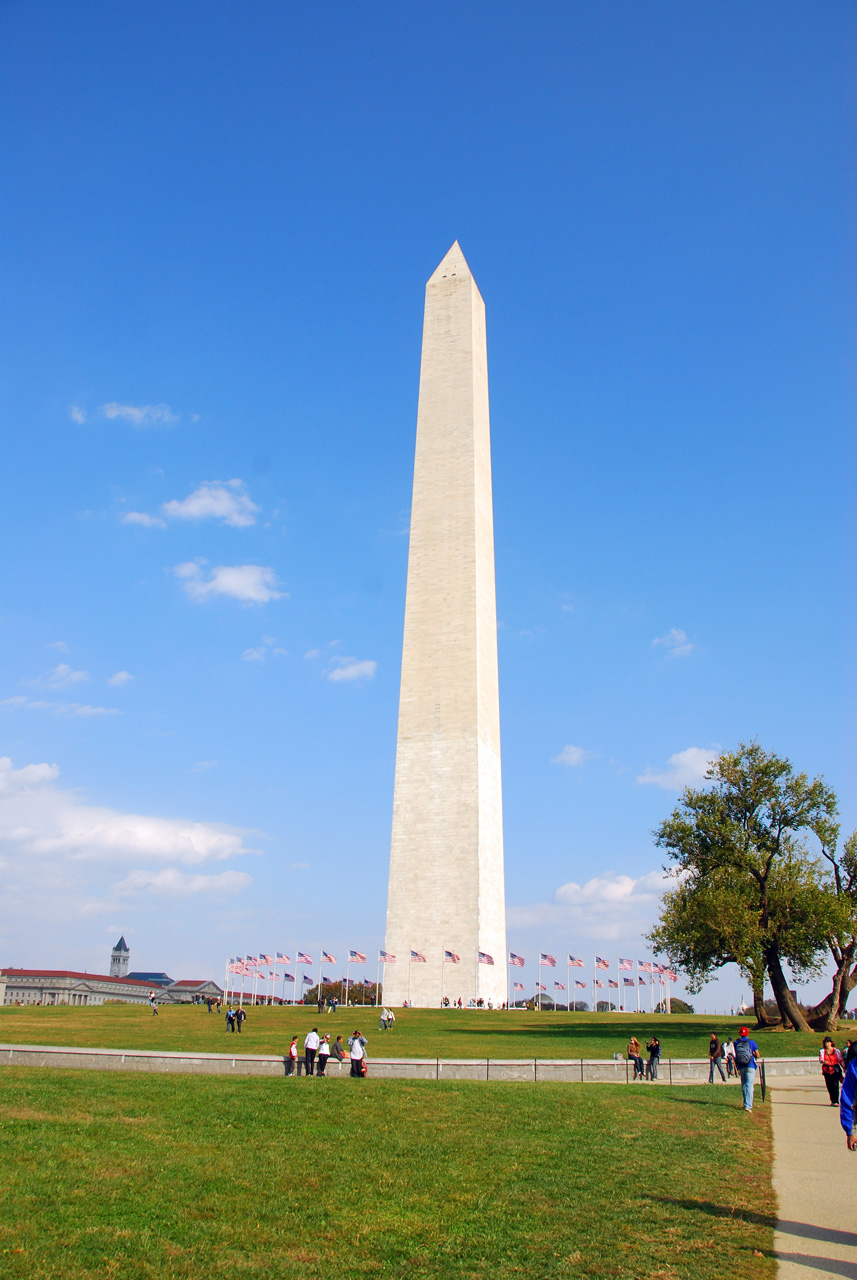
[[0, 1005, 828, 1059]]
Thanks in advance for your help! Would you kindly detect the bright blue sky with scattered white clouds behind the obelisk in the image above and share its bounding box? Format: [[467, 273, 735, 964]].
[[0, 0, 857, 1007]]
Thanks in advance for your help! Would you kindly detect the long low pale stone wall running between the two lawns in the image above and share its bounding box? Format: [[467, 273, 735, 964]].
[[0, 1044, 819, 1084]]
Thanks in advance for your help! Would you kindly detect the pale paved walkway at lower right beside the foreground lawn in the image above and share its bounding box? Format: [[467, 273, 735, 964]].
[[772, 1075, 857, 1280]]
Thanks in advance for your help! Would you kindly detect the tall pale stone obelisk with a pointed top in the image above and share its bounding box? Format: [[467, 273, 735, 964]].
[[384, 242, 507, 1009]]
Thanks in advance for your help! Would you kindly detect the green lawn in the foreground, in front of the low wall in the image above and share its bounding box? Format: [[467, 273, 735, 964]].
[[0, 1068, 776, 1280]]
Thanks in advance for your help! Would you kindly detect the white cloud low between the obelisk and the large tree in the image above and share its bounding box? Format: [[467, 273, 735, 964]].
[[507, 870, 675, 954]]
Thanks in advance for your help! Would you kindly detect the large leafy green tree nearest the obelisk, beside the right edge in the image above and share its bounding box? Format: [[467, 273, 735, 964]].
[[651, 742, 839, 1030]]
